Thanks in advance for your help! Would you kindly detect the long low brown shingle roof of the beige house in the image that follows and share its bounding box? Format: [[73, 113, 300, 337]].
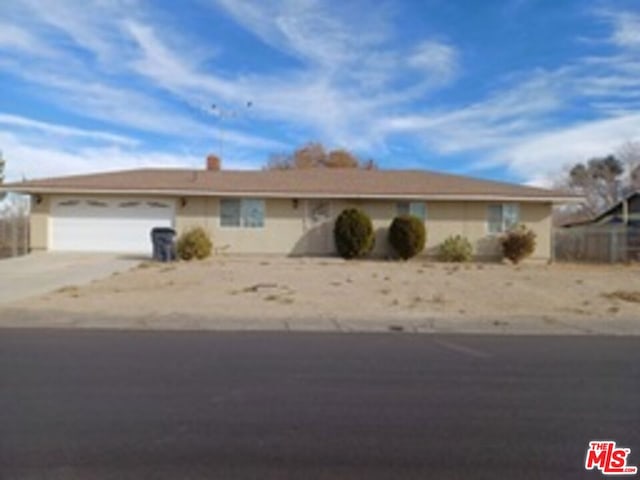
[[0, 168, 579, 202]]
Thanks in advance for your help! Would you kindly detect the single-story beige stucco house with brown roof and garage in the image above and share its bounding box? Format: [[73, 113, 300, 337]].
[[3, 160, 575, 260]]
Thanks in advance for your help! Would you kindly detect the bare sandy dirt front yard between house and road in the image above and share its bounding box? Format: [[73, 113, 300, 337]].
[[0, 257, 640, 334]]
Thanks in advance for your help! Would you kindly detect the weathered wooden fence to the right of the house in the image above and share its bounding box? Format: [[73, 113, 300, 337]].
[[553, 225, 640, 263]]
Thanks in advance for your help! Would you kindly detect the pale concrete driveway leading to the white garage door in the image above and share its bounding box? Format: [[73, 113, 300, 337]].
[[0, 253, 143, 305]]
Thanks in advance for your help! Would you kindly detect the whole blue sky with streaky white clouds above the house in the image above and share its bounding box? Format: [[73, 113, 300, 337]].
[[0, 0, 640, 185]]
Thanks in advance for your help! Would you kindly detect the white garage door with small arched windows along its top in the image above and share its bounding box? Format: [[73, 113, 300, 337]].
[[50, 197, 175, 253]]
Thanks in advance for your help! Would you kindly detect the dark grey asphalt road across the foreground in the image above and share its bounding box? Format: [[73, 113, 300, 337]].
[[0, 330, 640, 480]]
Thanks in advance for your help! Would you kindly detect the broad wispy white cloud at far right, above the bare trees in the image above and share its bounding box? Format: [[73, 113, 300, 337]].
[[378, 6, 640, 185]]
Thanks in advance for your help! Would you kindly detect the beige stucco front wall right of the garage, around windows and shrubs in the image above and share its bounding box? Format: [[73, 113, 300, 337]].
[[176, 198, 551, 260]]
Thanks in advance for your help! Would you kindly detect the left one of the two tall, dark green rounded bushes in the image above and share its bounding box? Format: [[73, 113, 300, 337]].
[[333, 208, 375, 259]]
